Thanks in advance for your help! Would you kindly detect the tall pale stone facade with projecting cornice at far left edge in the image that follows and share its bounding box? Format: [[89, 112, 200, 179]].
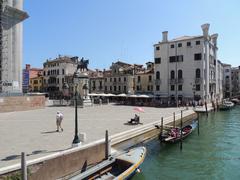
[[0, 0, 28, 94]]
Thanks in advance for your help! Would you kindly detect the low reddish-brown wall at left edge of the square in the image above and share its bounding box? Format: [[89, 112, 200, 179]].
[[0, 95, 45, 113]]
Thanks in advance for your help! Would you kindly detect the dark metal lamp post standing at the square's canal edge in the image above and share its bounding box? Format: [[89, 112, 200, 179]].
[[72, 73, 80, 145]]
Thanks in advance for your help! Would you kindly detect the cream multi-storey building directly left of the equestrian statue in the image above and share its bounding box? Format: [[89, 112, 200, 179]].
[[43, 55, 78, 99]]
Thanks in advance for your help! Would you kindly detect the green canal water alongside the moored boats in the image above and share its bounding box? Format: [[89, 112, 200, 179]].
[[132, 106, 240, 180]]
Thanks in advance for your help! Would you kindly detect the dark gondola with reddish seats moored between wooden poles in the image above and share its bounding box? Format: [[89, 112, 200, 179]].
[[160, 121, 198, 143]]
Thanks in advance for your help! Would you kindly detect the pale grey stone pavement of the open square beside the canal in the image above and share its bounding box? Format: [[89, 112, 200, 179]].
[[0, 104, 187, 168]]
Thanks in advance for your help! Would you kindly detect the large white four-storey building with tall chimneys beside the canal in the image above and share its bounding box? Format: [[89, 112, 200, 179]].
[[154, 24, 221, 103]]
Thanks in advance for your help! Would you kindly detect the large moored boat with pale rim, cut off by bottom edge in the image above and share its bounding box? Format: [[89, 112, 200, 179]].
[[71, 147, 146, 180]]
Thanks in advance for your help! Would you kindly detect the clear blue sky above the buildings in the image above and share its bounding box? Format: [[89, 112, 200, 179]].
[[23, 0, 240, 69]]
